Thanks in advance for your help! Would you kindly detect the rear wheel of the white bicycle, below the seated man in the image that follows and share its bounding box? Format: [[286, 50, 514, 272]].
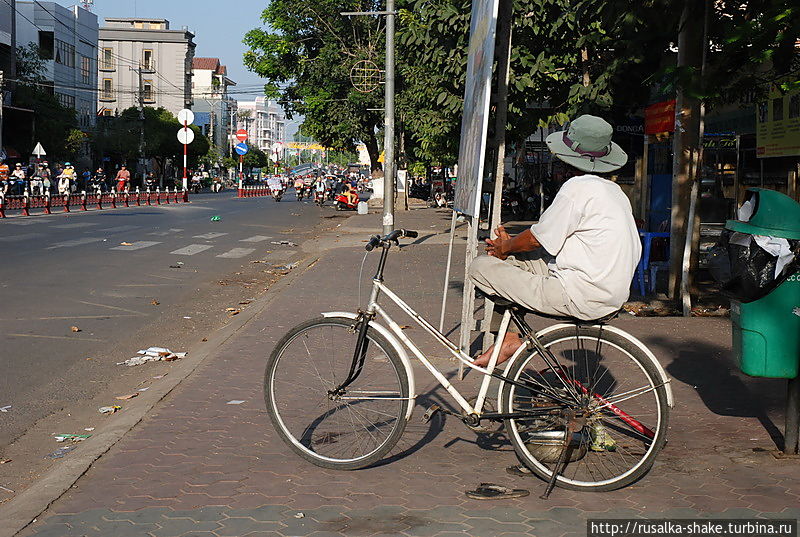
[[502, 326, 669, 491]]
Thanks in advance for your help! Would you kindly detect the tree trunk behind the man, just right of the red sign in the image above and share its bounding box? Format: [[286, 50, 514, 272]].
[[669, 0, 704, 298]]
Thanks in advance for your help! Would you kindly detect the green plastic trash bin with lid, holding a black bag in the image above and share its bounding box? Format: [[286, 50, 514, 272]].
[[725, 188, 800, 379]]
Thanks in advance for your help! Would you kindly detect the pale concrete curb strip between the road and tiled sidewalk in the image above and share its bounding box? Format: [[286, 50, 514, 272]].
[[0, 251, 324, 537]]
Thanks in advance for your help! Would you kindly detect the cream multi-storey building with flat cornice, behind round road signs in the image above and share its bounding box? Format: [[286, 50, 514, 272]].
[[97, 18, 195, 115]]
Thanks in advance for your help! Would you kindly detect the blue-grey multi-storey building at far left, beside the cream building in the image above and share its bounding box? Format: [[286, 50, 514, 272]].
[[16, 1, 98, 130]]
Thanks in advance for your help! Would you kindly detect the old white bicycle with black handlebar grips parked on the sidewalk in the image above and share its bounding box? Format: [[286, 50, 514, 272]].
[[264, 230, 673, 497]]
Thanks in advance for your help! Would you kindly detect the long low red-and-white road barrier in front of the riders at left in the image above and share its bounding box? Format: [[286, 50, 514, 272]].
[[0, 187, 189, 218]]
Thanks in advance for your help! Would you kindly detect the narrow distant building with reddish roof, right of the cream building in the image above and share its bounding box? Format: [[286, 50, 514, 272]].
[[192, 58, 236, 152]]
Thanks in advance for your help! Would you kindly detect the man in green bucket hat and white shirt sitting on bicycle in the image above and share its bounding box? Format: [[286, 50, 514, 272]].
[[469, 115, 641, 367]]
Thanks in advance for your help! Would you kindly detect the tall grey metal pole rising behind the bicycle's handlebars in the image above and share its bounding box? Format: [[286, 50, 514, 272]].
[[383, 0, 395, 234]]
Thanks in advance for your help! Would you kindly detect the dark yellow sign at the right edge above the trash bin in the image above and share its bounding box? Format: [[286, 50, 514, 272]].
[[756, 84, 800, 157]]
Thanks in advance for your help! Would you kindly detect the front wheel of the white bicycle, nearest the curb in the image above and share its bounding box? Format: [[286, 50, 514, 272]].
[[264, 317, 411, 470]]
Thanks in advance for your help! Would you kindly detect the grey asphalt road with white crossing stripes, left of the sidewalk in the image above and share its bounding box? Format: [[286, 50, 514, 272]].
[[0, 188, 332, 449]]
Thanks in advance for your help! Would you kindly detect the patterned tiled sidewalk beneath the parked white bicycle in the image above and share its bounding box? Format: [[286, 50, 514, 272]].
[[17, 211, 800, 537]]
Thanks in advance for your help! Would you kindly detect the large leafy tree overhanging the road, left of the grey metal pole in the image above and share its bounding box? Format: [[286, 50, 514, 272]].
[[244, 0, 384, 171]]
